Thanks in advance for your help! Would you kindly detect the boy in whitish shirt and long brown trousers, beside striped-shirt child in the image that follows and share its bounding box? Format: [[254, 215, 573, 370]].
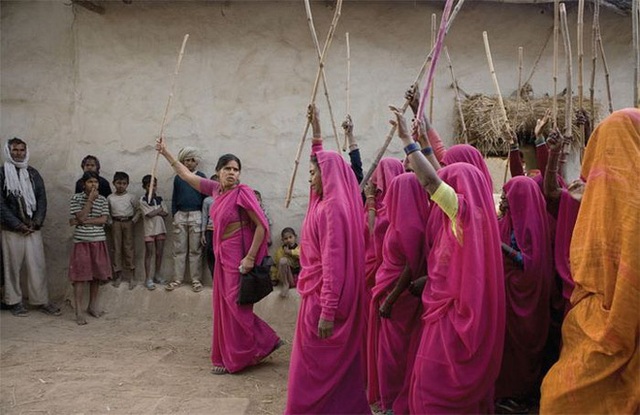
[[107, 171, 140, 290]]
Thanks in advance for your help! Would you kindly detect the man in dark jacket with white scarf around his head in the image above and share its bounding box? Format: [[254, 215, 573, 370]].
[[0, 138, 60, 317]]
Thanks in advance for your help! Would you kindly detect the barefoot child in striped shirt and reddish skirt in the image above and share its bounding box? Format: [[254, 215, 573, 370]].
[[69, 171, 111, 325]]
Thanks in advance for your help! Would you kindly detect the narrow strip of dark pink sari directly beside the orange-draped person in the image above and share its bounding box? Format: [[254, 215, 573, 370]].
[[554, 189, 580, 308]]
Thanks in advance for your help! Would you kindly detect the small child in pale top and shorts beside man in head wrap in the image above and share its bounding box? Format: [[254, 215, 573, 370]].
[[139, 174, 169, 290]]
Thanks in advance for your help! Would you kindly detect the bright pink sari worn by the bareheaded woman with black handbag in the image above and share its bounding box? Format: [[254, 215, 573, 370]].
[[200, 179, 279, 373]]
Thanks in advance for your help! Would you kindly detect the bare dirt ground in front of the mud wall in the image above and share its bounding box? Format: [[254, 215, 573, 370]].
[[0, 283, 299, 414]]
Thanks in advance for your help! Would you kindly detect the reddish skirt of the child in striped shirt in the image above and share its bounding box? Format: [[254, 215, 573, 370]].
[[69, 241, 112, 282]]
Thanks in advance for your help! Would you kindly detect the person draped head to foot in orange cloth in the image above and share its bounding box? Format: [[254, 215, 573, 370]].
[[540, 108, 640, 414]]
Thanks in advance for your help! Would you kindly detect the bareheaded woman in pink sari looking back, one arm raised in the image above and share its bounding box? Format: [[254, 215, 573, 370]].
[[156, 138, 282, 375]]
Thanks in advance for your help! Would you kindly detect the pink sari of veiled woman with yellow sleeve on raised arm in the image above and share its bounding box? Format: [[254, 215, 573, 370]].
[[409, 163, 505, 414]]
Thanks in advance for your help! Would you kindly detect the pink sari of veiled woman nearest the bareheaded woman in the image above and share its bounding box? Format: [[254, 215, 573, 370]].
[[286, 151, 370, 414]]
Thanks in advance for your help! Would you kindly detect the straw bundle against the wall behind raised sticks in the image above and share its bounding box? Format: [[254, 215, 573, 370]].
[[456, 94, 600, 156]]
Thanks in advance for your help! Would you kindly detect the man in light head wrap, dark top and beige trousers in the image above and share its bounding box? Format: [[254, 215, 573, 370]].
[[165, 147, 206, 292]]
